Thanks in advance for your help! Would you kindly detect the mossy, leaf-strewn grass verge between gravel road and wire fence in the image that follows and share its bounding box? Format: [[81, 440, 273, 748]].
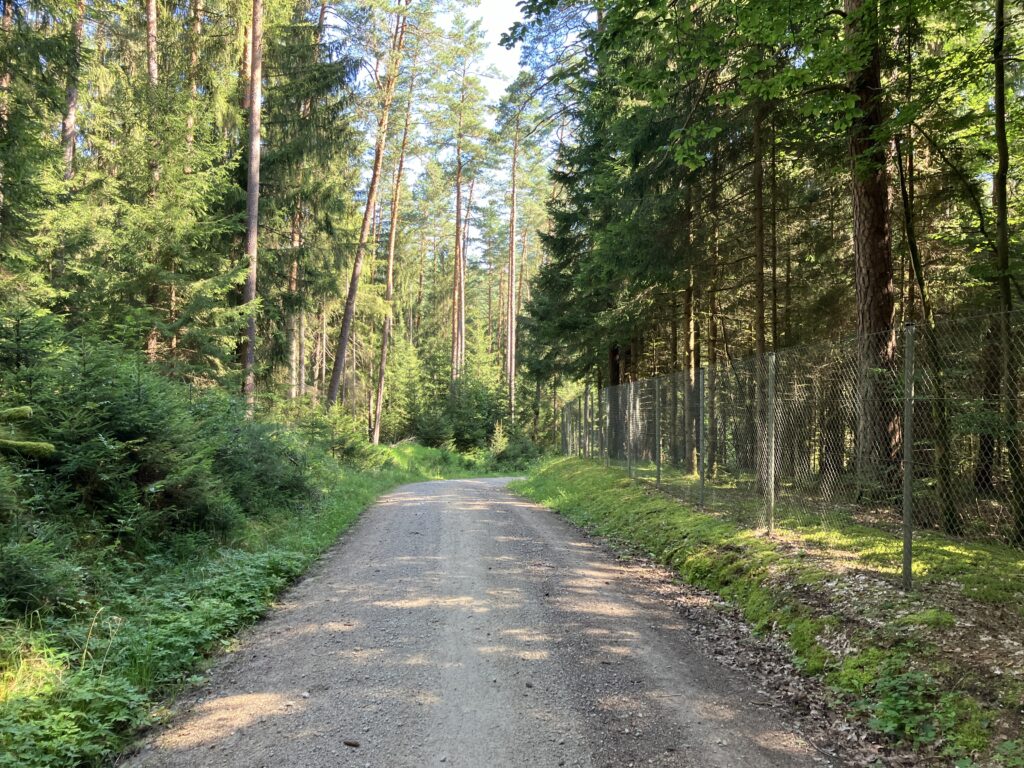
[[514, 459, 1024, 768]]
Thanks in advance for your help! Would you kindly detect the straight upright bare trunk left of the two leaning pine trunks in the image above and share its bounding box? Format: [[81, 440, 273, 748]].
[[240, 0, 263, 417]]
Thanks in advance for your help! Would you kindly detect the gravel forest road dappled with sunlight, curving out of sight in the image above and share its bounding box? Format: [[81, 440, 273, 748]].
[[128, 479, 825, 768]]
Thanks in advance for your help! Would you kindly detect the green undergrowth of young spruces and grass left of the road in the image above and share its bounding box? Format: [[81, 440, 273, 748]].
[[0, 342, 528, 768]]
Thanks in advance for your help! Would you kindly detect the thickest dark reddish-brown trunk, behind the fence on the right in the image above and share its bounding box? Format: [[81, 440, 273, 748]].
[[846, 0, 899, 496]]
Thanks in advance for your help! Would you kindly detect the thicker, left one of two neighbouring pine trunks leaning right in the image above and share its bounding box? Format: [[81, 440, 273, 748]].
[[327, 0, 411, 408]]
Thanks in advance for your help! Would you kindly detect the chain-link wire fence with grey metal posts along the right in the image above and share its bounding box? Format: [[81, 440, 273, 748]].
[[561, 313, 1024, 587]]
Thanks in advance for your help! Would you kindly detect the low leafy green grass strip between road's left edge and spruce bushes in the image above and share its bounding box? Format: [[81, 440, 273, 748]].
[[0, 443, 460, 768]]
